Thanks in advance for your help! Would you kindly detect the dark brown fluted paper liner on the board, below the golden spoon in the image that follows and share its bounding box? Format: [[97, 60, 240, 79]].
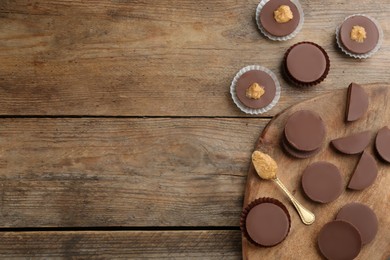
[[240, 197, 291, 247]]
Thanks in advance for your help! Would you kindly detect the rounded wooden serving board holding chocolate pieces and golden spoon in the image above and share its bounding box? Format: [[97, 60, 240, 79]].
[[242, 84, 390, 260]]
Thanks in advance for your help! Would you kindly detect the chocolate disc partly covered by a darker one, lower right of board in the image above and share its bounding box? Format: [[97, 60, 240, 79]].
[[336, 203, 378, 245]]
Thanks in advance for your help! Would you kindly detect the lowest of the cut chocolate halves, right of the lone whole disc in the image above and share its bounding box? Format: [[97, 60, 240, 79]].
[[348, 151, 378, 190]]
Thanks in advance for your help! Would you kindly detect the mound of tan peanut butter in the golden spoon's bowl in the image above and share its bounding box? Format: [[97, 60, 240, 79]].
[[252, 151, 278, 180]]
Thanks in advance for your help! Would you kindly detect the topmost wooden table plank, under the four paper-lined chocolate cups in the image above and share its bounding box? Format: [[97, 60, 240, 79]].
[[0, 0, 390, 116]]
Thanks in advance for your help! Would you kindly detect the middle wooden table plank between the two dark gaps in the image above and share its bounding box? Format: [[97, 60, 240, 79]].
[[0, 118, 268, 228]]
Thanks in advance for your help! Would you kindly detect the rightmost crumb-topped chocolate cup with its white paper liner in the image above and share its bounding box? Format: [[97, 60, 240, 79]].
[[336, 14, 383, 58]]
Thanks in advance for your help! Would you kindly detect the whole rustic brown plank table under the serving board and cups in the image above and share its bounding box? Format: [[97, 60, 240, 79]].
[[0, 0, 390, 259]]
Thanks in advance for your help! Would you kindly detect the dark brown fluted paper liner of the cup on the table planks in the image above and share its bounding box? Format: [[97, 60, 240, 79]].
[[282, 41, 330, 87]]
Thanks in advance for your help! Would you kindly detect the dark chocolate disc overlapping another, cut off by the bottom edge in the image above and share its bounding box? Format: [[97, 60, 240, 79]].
[[318, 220, 362, 260]]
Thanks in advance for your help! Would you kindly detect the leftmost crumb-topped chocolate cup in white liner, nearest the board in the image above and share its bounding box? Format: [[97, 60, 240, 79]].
[[230, 65, 281, 114]]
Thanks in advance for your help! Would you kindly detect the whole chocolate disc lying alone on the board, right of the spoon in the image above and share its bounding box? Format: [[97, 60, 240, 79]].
[[302, 162, 343, 203]]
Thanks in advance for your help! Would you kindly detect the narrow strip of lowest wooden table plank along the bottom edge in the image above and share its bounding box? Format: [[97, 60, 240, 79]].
[[0, 230, 241, 259]]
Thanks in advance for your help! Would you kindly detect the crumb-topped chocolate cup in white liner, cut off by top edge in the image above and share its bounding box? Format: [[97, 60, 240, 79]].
[[256, 0, 304, 41]]
